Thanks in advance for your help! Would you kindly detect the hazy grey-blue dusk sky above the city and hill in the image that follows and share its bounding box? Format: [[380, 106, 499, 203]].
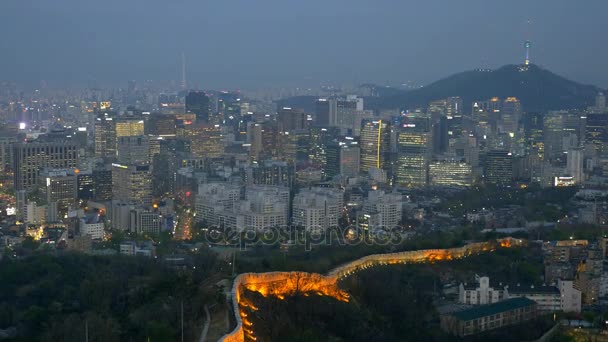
[[0, 0, 608, 88]]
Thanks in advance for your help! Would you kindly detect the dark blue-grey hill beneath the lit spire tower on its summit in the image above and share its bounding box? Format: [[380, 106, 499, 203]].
[[368, 65, 601, 112]]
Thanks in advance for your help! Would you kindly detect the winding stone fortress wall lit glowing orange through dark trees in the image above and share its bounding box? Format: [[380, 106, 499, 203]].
[[220, 238, 525, 342]]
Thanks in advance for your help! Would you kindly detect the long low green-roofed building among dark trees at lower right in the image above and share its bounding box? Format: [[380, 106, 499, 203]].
[[441, 297, 538, 337]]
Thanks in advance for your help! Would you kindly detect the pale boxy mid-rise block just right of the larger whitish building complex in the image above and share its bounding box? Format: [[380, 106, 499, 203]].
[[292, 188, 344, 232]]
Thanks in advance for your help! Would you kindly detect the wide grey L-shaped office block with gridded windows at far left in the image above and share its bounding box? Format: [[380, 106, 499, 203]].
[[13, 142, 78, 190]]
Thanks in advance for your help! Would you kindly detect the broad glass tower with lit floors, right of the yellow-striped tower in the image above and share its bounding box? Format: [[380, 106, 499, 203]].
[[395, 125, 432, 187]]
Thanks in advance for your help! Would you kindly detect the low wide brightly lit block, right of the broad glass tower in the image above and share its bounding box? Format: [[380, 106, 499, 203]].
[[429, 160, 473, 186]]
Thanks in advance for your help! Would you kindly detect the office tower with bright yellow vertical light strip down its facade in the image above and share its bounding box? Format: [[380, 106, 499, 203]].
[[360, 120, 391, 172]]
